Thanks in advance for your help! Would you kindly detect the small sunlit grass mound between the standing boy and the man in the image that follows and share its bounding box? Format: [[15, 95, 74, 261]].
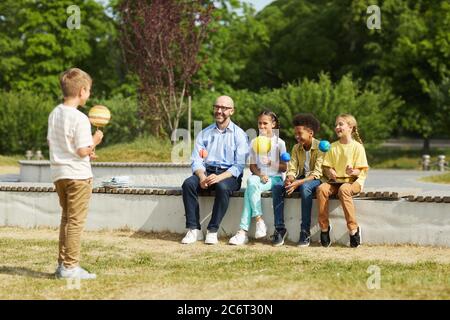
[[96, 137, 172, 162]]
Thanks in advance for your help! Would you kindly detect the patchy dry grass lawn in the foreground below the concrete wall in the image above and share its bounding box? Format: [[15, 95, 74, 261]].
[[0, 227, 450, 299]]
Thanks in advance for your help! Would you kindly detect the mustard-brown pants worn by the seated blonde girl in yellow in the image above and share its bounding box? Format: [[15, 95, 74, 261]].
[[317, 182, 361, 231]]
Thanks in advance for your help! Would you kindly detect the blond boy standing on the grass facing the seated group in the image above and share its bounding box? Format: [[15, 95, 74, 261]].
[[47, 68, 103, 279]]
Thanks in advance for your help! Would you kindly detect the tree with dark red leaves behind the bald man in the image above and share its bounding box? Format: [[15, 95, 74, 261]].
[[119, 0, 214, 135]]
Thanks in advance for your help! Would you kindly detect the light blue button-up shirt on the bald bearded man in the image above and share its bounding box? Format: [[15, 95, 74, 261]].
[[191, 121, 249, 178]]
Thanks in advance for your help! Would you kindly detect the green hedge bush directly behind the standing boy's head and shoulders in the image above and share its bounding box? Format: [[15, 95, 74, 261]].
[[0, 91, 142, 155]]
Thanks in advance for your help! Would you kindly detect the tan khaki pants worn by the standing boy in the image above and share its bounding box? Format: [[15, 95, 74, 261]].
[[55, 178, 92, 268]]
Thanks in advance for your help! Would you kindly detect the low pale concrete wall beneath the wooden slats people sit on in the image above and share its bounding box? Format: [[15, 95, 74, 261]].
[[0, 191, 450, 247]]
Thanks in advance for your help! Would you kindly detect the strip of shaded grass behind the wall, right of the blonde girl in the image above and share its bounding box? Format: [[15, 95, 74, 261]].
[[366, 147, 450, 170]]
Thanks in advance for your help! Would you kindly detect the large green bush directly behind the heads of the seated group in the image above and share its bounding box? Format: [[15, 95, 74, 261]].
[[192, 74, 402, 149]]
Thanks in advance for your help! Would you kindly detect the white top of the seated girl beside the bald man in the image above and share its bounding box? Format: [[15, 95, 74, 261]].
[[249, 135, 286, 178]]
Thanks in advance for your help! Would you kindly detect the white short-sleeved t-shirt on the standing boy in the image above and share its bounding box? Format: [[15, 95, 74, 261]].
[[47, 104, 94, 181]]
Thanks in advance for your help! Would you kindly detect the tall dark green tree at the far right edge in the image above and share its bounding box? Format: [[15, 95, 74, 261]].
[[361, 0, 450, 151]]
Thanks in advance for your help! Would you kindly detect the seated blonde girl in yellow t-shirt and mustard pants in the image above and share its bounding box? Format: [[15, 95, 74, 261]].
[[317, 114, 369, 248]]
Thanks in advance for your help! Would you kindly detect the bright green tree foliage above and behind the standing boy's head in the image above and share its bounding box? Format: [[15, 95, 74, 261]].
[[0, 0, 122, 97]]
